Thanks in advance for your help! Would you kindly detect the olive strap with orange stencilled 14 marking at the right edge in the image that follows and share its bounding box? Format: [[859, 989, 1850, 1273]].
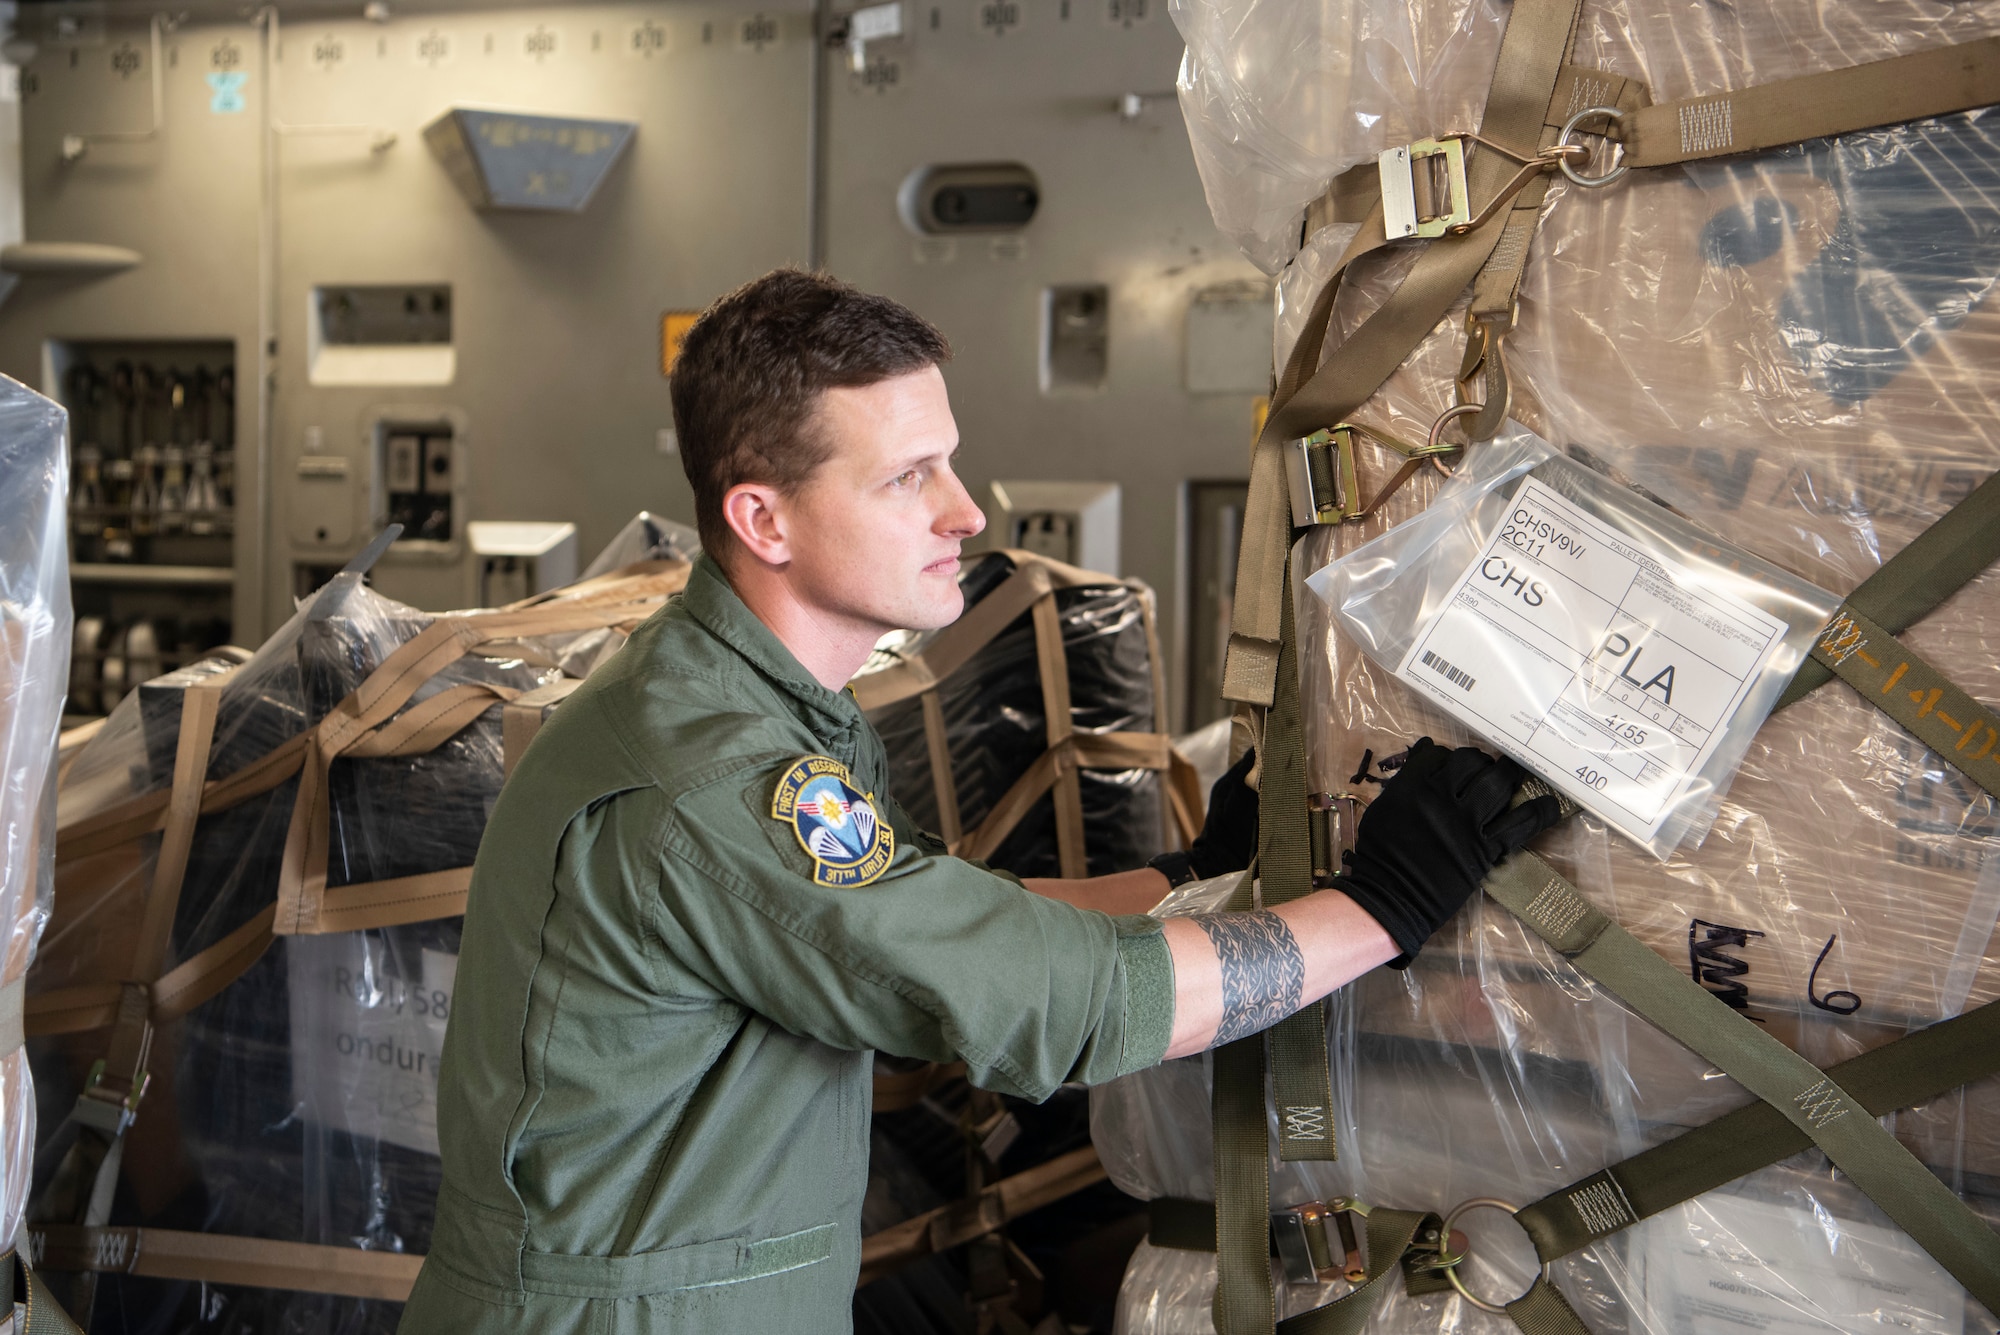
[[1812, 608, 2000, 797]]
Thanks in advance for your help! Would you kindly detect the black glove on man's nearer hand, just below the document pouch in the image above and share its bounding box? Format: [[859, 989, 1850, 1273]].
[[1336, 737, 1562, 969]]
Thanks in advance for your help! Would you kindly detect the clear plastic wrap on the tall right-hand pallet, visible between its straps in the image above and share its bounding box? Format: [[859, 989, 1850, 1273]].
[[1092, 0, 2000, 1335]]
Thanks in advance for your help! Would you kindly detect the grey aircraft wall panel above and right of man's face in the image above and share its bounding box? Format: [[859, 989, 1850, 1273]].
[[826, 0, 1258, 731]]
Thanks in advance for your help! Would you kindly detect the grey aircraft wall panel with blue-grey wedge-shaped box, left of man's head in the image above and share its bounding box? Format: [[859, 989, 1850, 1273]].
[[0, 4, 812, 638]]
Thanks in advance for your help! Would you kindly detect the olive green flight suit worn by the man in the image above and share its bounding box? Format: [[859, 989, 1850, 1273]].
[[400, 560, 1174, 1335]]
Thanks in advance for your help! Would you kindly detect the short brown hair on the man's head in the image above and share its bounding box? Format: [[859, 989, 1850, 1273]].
[[672, 268, 952, 558]]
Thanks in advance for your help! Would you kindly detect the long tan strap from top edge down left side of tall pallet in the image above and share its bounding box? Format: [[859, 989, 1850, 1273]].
[[1222, 0, 1582, 705]]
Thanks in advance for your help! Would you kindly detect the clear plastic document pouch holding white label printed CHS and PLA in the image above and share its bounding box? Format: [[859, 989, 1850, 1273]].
[[1308, 430, 1838, 859]]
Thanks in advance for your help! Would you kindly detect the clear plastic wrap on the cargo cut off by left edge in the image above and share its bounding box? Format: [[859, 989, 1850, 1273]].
[[0, 378, 70, 1271]]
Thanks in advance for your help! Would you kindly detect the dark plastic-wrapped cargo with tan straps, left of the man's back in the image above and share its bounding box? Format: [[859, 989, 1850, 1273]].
[[28, 566, 686, 1335]]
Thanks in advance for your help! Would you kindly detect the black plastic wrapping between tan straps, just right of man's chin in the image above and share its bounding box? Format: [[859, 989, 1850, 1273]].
[[870, 552, 1166, 877]]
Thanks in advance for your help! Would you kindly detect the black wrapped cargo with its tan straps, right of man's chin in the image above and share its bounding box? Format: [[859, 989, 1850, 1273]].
[[854, 552, 1178, 877]]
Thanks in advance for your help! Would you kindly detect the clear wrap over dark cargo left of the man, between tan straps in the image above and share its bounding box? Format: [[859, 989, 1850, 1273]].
[[30, 574, 680, 1335]]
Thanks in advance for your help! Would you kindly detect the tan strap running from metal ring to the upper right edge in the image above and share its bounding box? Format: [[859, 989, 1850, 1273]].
[[1620, 38, 2000, 168]]
